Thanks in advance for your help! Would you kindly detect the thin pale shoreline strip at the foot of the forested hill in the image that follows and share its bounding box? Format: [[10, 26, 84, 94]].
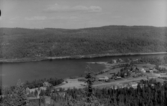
[[0, 52, 167, 63]]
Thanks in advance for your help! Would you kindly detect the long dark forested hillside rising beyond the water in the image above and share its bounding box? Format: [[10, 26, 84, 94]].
[[0, 26, 167, 59]]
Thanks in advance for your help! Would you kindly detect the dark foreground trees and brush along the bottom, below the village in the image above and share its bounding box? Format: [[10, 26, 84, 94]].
[[1, 80, 167, 106]]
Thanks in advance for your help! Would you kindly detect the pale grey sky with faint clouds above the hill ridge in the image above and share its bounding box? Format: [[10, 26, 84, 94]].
[[0, 0, 167, 29]]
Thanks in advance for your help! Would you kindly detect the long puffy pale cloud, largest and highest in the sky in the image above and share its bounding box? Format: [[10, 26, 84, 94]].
[[45, 4, 102, 12]]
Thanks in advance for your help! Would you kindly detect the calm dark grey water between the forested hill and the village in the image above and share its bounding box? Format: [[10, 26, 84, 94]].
[[0, 55, 166, 86]]
